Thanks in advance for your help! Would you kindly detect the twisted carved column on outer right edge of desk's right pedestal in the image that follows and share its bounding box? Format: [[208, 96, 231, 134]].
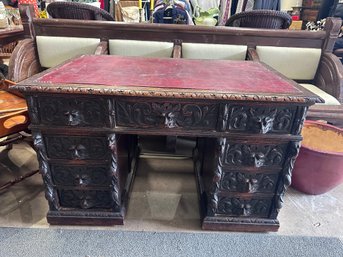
[[271, 142, 301, 218]]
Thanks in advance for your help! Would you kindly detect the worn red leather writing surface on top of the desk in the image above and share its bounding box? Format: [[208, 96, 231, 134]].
[[36, 55, 301, 94]]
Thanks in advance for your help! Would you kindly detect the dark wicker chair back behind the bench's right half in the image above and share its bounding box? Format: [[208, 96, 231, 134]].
[[225, 10, 292, 29]]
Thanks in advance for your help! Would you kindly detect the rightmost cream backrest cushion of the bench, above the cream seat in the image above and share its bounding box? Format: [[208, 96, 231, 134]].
[[256, 46, 321, 80]]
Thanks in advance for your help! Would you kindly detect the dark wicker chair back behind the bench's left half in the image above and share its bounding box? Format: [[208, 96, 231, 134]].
[[47, 2, 114, 21]]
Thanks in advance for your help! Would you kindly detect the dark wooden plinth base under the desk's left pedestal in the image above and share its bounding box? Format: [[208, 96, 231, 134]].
[[47, 211, 124, 226]]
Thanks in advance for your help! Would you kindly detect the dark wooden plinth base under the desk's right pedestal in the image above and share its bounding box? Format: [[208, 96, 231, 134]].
[[202, 217, 280, 232]]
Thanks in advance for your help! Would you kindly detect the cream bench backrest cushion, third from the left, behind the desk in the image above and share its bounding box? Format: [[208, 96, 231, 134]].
[[182, 43, 248, 60]]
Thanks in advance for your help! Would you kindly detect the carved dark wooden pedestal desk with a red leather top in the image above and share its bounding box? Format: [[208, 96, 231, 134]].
[[14, 56, 320, 231]]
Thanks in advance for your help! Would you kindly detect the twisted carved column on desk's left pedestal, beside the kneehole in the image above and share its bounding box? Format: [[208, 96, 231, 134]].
[[108, 134, 121, 211]]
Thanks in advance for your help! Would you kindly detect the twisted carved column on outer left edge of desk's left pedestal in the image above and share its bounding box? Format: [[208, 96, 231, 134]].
[[32, 131, 60, 211]]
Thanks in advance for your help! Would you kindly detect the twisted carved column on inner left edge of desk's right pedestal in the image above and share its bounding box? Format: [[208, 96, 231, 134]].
[[207, 138, 226, 216]]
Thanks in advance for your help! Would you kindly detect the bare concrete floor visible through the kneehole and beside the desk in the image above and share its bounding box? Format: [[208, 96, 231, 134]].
[[0, 137, 343, 240]]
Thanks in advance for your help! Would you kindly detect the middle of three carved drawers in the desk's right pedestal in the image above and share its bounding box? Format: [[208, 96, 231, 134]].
[[220, 172, 279, 193]]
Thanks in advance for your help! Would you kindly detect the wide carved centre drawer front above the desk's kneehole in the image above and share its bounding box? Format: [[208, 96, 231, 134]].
[[116, 101, 218, 130]]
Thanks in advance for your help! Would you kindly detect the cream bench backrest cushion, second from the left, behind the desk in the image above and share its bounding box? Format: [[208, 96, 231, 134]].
[[108, 39, 174, 58]]
